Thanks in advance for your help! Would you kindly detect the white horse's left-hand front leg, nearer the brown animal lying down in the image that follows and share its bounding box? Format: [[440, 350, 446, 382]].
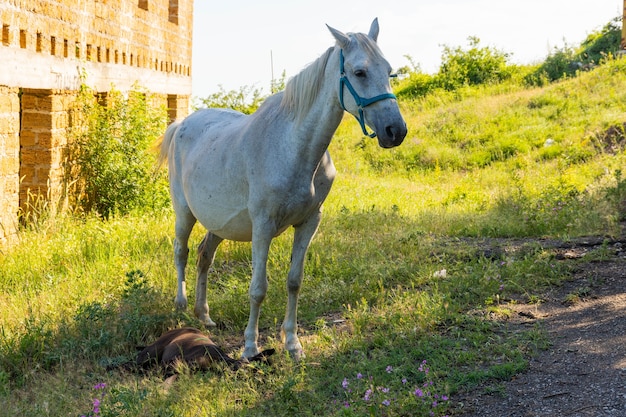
[[242, 223, 276, 358]]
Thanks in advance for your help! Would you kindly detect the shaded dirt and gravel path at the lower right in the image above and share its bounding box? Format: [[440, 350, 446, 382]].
[[454, 239, 626, 417]]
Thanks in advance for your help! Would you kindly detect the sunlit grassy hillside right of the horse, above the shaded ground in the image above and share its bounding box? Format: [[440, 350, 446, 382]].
[[331, 60, 626, 237]]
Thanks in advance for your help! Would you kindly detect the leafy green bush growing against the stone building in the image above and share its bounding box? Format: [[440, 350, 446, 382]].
[[67, 85, 169, 218]]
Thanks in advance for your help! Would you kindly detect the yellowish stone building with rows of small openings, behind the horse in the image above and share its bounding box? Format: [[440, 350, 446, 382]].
[[0, 0, 193, 247]]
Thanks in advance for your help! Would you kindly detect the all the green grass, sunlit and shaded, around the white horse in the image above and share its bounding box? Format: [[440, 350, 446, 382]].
[[0, 60, 626, 416]]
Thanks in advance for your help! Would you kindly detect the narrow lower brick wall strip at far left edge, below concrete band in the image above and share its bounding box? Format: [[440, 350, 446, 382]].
[[0, 86, 20, 247]]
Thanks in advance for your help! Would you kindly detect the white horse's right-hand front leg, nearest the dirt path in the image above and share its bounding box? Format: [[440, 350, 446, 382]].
[[281, 211, 321, 360]]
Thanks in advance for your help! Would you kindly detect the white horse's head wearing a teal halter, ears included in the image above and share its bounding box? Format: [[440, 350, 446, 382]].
[[328, 19, 407, 148]]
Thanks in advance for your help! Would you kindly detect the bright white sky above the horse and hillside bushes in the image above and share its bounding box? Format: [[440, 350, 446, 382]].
[[192, 0, 623, 98]]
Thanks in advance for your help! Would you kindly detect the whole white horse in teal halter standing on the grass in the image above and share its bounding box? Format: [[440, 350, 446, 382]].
[[159, 19, 407, 358]]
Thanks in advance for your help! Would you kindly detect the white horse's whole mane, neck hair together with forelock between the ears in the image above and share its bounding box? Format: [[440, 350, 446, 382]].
[[281, 33, 382, 121]]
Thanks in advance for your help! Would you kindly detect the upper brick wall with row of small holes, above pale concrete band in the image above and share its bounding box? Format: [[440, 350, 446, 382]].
[[0, 0, 193, 83]]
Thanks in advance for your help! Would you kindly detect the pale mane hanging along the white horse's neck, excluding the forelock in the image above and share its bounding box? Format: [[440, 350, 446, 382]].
[[281, 47, 339, 120]]
